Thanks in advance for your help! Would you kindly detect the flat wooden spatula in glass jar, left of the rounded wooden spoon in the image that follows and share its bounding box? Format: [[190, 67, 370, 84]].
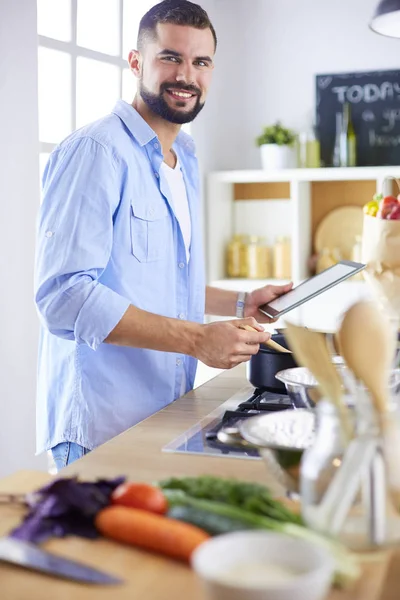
[[286, 323, 353, 440]]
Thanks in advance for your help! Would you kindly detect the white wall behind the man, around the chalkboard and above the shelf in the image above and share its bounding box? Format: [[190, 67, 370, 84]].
[[194, 0, 400, 170]]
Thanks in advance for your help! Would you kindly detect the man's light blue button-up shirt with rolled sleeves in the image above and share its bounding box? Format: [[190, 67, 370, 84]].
[[35, 101, 205, 453]]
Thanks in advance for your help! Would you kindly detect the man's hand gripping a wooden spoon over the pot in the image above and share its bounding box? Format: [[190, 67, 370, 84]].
[[194, 319, 271, 369]]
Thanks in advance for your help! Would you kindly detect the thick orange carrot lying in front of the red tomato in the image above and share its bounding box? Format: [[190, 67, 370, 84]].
[[95, 506, 210, 562]]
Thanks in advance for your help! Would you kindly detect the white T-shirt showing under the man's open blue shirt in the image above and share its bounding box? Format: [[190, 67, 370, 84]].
[[161, 158, 192, 262]]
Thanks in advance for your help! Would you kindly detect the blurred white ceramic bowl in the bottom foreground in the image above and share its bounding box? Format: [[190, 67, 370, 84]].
[[191, 531, 334, 600]]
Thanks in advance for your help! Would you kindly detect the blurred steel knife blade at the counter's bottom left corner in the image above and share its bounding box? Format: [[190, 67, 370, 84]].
[[0, 537, 122, 584]]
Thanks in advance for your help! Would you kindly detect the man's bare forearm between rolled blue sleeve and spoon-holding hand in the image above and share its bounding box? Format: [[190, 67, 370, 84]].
[[104, 305, 201, 356]]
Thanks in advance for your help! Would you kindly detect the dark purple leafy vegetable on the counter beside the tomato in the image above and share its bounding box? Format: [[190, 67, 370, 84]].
[[10, 477, 125, 544]]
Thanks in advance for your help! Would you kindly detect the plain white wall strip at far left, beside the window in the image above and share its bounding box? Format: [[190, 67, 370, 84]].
[[0, 0, 46, 476]]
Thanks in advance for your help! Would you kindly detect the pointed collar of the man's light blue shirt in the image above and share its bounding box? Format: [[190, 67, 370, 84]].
[[111, 100, 195, 154]]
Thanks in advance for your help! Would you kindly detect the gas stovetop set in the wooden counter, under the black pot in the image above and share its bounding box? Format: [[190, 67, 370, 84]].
[[163, 387, 292, 459]]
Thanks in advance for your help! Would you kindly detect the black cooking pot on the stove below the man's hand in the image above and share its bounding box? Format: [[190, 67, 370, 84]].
[[247, 333, 298, 392]]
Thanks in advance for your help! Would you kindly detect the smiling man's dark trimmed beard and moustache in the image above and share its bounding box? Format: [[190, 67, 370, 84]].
[[139, 79, 204, 125]]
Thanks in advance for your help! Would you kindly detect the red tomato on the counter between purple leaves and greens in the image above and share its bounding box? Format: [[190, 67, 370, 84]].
[[111, 482, 168, 515]]
